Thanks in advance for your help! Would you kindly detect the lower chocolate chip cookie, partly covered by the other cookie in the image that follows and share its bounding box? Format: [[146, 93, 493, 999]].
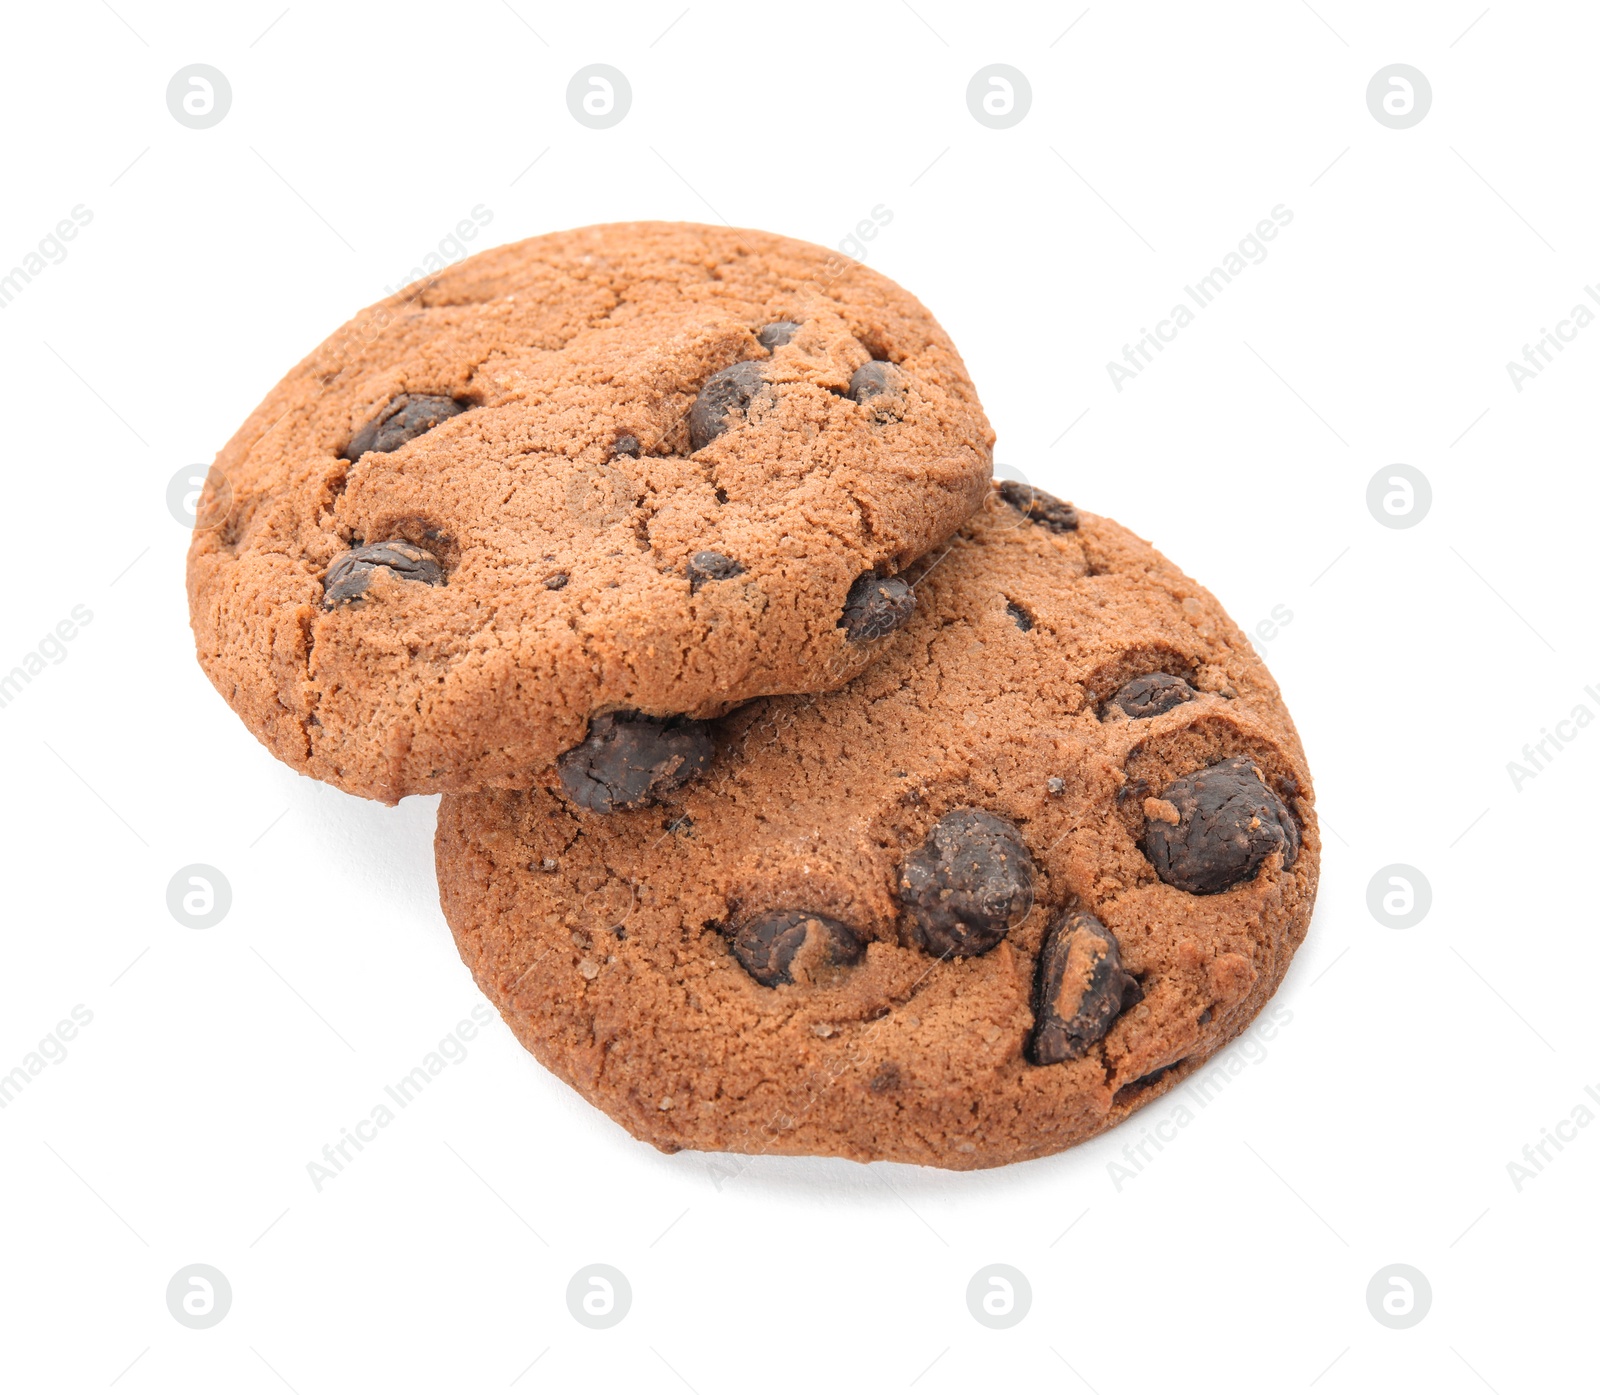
[[435, 495, 1320, 1168]]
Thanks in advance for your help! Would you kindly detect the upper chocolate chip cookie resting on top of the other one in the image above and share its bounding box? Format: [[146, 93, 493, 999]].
[[189, 222, 994, 801]]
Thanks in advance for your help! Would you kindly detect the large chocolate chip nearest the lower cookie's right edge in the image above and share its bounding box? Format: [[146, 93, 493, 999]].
[[1139, 755, 1299, 896]]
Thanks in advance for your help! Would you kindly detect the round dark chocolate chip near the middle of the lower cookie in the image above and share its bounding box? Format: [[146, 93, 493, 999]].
[[899, 809, 1034, 958]]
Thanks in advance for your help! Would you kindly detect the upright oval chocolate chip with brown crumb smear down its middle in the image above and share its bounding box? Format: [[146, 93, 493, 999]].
[[1027, 910, 1144, 1065]]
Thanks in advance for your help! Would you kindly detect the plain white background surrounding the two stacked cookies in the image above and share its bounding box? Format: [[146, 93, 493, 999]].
[[0, 0, 1600, 1395]]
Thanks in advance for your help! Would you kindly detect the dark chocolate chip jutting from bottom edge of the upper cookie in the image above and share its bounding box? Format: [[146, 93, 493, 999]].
[[557, 712, 712, 814]]
